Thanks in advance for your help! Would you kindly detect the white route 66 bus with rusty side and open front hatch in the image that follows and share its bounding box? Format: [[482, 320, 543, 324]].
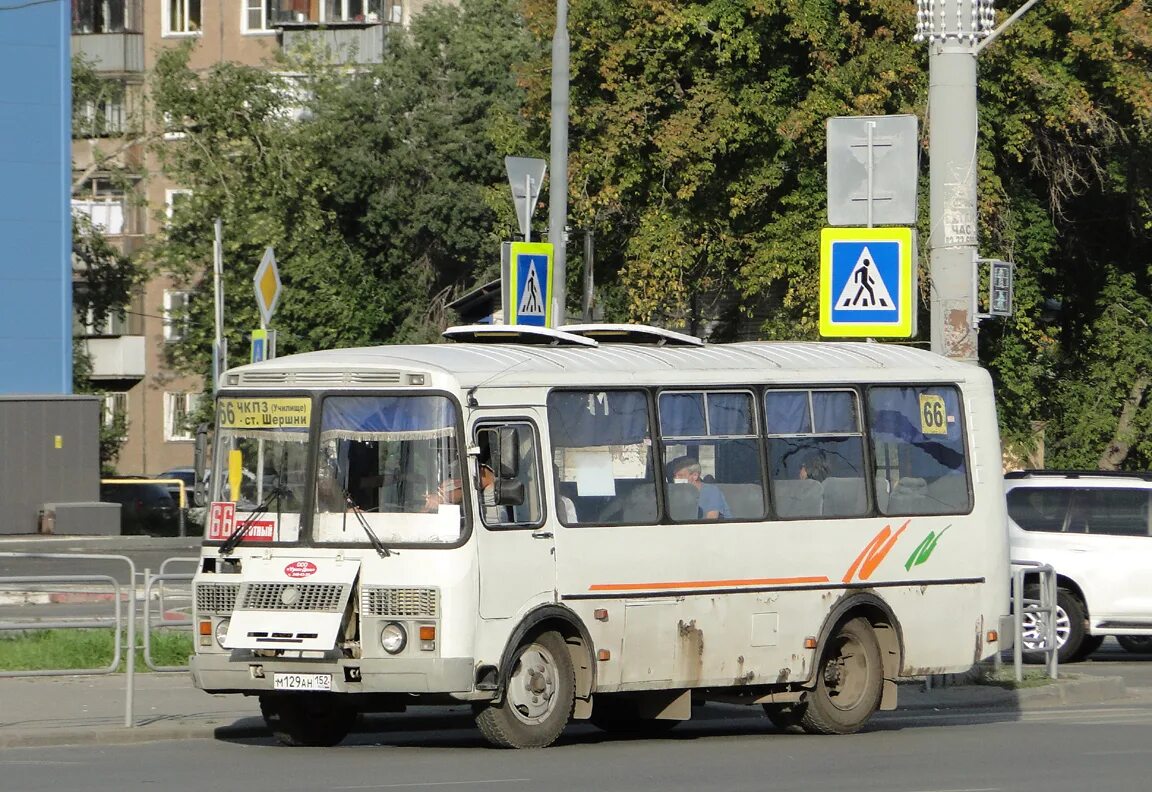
[[192, 325, 1010, 747]]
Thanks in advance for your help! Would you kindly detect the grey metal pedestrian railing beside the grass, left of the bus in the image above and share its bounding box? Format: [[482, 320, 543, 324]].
[[0, 553, 197, 726]]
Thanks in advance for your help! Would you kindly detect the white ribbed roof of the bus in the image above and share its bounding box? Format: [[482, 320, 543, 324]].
[[222, 342, 987, 388]]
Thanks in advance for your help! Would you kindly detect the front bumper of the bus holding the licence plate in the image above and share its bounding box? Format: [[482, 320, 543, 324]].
[[189, 654, 476, 693]]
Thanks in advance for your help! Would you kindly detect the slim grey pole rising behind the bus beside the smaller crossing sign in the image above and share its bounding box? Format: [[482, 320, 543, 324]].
[[548, 0, 569, 327]]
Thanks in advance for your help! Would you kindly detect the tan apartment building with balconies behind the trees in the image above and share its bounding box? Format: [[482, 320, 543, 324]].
[[71, 0, 440, 474]]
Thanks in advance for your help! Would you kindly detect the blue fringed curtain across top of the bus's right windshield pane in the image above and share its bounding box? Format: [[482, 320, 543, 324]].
[[321, 396, 456, 440]]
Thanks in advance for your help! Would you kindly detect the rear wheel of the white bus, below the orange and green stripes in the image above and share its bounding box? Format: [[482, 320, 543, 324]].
[[799, 618, 884, 734]]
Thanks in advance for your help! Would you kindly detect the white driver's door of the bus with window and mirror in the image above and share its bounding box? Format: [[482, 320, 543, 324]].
[[473, 417, 556, 618]]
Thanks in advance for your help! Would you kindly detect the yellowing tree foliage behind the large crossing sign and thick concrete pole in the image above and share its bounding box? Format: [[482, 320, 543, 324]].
[[526, 0, 1152, 467]]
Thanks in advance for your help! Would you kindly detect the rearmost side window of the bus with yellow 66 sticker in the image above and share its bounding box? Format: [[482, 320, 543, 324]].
[[869, 387, 971, 516]]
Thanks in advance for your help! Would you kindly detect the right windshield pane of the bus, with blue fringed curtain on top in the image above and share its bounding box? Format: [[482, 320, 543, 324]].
[[312, 396, 464, 545]]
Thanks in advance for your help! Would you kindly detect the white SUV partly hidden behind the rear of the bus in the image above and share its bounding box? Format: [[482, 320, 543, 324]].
[[1005, 471, 1152, 663]]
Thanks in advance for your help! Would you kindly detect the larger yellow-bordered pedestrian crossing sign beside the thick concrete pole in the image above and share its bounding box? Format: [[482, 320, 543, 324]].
[[820, 228, 916, 338]]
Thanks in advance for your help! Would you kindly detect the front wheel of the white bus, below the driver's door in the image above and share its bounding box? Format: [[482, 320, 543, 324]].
[[476, 631, 576, 748]]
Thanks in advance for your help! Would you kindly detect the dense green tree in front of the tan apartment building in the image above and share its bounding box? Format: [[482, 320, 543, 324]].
[[151, 0, 535, 384]]
